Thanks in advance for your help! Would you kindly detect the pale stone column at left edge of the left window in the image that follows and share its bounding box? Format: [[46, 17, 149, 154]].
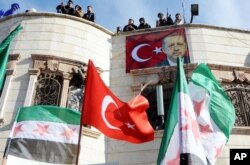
[[24, 69, 40, 106]]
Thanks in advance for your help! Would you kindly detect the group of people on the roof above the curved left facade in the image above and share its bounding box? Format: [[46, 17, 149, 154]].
[[56, 0, 95, 22]]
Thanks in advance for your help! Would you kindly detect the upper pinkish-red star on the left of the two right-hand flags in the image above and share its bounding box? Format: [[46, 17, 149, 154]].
[[181, 110, 200, 142]]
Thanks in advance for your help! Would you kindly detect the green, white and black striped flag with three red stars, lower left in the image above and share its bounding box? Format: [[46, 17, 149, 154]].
[[6, 106, 80, 165]]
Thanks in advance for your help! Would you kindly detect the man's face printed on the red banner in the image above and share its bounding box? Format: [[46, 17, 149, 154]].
[[162, 35, 187, 59]]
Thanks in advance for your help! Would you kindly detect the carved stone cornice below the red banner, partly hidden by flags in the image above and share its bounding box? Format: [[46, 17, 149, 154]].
[[129, 63, 250, 91]]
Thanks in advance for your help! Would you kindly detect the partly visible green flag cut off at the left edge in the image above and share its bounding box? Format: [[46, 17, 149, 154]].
[[0, 25, 23, 91]]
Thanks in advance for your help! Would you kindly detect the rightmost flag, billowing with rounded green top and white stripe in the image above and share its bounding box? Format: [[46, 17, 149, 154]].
[[189, 64, 235, 164]]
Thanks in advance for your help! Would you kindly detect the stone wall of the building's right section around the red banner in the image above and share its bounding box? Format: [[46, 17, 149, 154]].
[[110, 25, 250, 165]]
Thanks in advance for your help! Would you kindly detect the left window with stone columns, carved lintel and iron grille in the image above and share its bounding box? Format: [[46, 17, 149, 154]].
[[29, 55, 87, 111]]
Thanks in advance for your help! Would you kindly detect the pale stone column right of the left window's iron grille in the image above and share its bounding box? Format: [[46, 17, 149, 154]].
[[60, 73, 73, 107]]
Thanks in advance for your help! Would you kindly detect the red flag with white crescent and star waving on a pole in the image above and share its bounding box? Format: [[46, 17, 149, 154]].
[[82, 60, 154, 143]]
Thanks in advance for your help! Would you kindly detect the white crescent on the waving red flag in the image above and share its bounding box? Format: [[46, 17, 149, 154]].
[[102, 95, 120, 130]]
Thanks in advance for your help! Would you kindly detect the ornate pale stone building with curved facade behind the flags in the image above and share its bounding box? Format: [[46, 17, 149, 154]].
[[0, 13, 250, 165]]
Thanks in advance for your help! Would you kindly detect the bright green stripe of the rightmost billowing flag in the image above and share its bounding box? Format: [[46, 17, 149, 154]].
[[191, 64, 235, 138]]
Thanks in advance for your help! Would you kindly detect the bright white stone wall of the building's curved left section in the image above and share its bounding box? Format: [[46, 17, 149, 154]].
[[0, 13, 112, 163]]
